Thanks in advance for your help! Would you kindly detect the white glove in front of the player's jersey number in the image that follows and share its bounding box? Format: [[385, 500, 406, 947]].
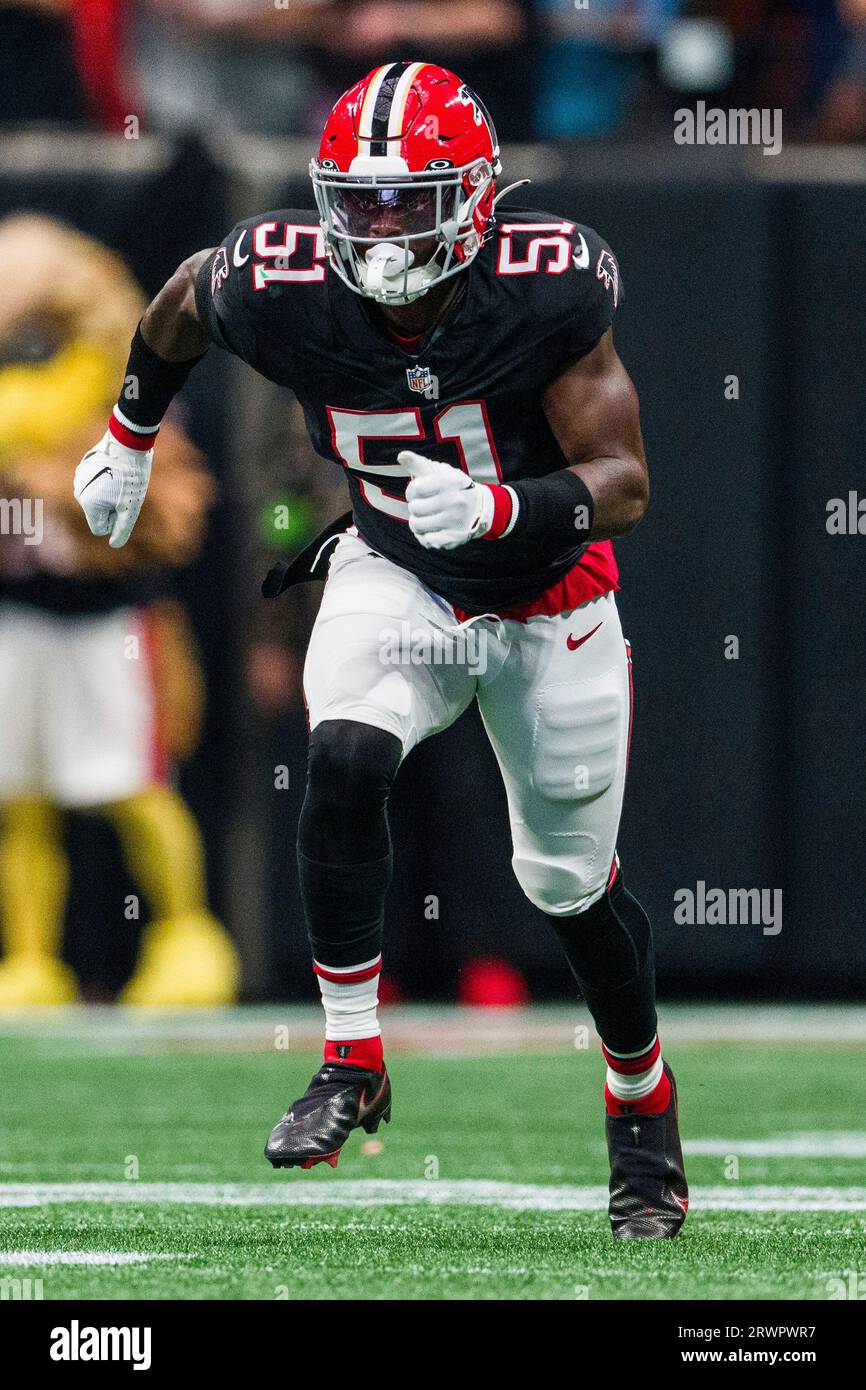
[[398, 449, 493, 550]]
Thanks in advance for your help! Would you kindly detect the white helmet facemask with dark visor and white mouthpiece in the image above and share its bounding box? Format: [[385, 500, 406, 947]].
[[310, 156, 498, 304]]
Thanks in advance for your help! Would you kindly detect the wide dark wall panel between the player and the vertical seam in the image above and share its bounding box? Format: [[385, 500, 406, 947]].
[[532, 179, 781, 990]]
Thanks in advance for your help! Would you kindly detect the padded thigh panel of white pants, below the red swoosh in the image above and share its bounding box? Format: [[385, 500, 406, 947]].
[[531, 682, 626, 802]]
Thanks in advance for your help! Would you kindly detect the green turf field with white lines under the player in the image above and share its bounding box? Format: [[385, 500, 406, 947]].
[[0, 1009, 866, 1300]]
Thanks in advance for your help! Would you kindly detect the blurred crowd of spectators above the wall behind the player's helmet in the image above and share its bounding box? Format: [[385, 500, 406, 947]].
[[0, 0, 866, 140]]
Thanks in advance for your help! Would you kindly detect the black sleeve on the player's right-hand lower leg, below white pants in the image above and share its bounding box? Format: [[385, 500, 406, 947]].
[[548, 872, 656, 1052]]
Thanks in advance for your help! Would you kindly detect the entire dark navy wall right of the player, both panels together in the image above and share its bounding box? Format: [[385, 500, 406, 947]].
[[534, 179, 866, 997]]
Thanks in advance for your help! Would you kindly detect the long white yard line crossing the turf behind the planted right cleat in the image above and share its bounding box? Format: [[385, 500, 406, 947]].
[[0, 1177, 866, 1212]]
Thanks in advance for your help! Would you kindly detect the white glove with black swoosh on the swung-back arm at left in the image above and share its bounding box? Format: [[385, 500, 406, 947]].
[[72, 431, 153, 550]]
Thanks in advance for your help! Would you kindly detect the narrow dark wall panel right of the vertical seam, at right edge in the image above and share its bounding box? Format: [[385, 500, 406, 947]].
[[778, 185, 866, 995]]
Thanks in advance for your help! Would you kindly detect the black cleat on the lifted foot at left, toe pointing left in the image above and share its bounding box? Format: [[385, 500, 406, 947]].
[[264, 1062, 391, 1168]]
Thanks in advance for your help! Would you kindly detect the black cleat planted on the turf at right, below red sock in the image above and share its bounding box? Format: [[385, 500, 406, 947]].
[[606, 1062, 688, 1240]]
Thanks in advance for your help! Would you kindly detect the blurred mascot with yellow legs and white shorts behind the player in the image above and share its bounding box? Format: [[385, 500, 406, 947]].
[[0, 214, 239, 1008]]
